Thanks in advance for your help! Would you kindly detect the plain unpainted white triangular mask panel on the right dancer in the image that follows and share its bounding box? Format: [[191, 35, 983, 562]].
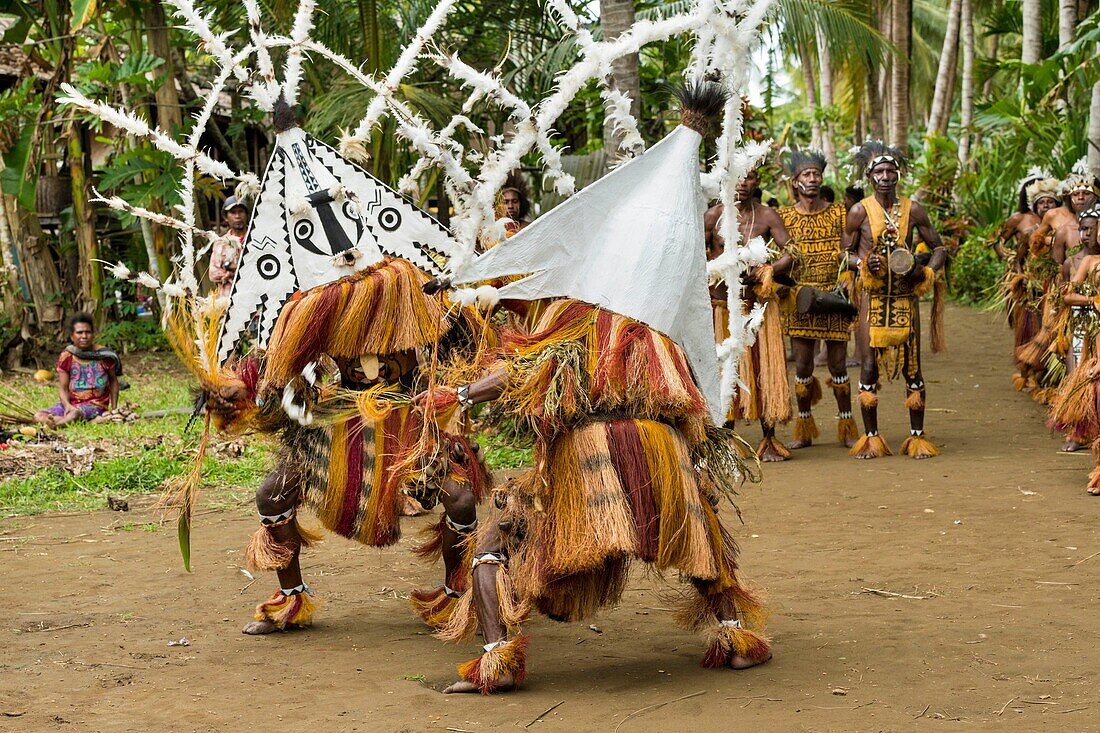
[[453, 127, 725, 425]]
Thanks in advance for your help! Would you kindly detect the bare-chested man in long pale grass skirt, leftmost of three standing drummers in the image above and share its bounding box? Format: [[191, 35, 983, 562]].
[[703, 169, 794, 462]]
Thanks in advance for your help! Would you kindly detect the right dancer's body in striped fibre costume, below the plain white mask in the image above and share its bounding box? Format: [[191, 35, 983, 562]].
[[440, 299, 770, 692]]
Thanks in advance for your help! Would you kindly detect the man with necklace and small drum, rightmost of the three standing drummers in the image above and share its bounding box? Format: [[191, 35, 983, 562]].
[[845, 140, 947, 459]]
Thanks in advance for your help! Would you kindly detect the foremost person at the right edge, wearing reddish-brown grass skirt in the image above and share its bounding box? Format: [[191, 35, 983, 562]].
[[1048, 205, 1100, 495]]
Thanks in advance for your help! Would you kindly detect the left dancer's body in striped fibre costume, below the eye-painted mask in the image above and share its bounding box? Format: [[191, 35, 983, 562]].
[[213, 259, 487, 628]]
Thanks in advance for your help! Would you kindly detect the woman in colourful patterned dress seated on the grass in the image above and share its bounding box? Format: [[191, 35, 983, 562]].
[[34, 313, 122, 427]]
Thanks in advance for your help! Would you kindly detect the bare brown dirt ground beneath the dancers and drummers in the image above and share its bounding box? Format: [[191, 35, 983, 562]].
[[0, 299, 1100, 733]]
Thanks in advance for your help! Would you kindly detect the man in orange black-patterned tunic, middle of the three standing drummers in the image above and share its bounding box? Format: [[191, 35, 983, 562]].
[[779, 151, 859, 450]]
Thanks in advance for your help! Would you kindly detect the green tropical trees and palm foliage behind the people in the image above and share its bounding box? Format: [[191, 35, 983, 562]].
[[0, 0, 1100, 367]]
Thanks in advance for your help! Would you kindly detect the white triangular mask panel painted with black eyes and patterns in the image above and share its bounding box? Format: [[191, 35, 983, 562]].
[[218, 128, 458, 362]]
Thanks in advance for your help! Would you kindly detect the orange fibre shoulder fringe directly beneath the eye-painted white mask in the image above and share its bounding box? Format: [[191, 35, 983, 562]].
[[264, 258, 449, 387]]
